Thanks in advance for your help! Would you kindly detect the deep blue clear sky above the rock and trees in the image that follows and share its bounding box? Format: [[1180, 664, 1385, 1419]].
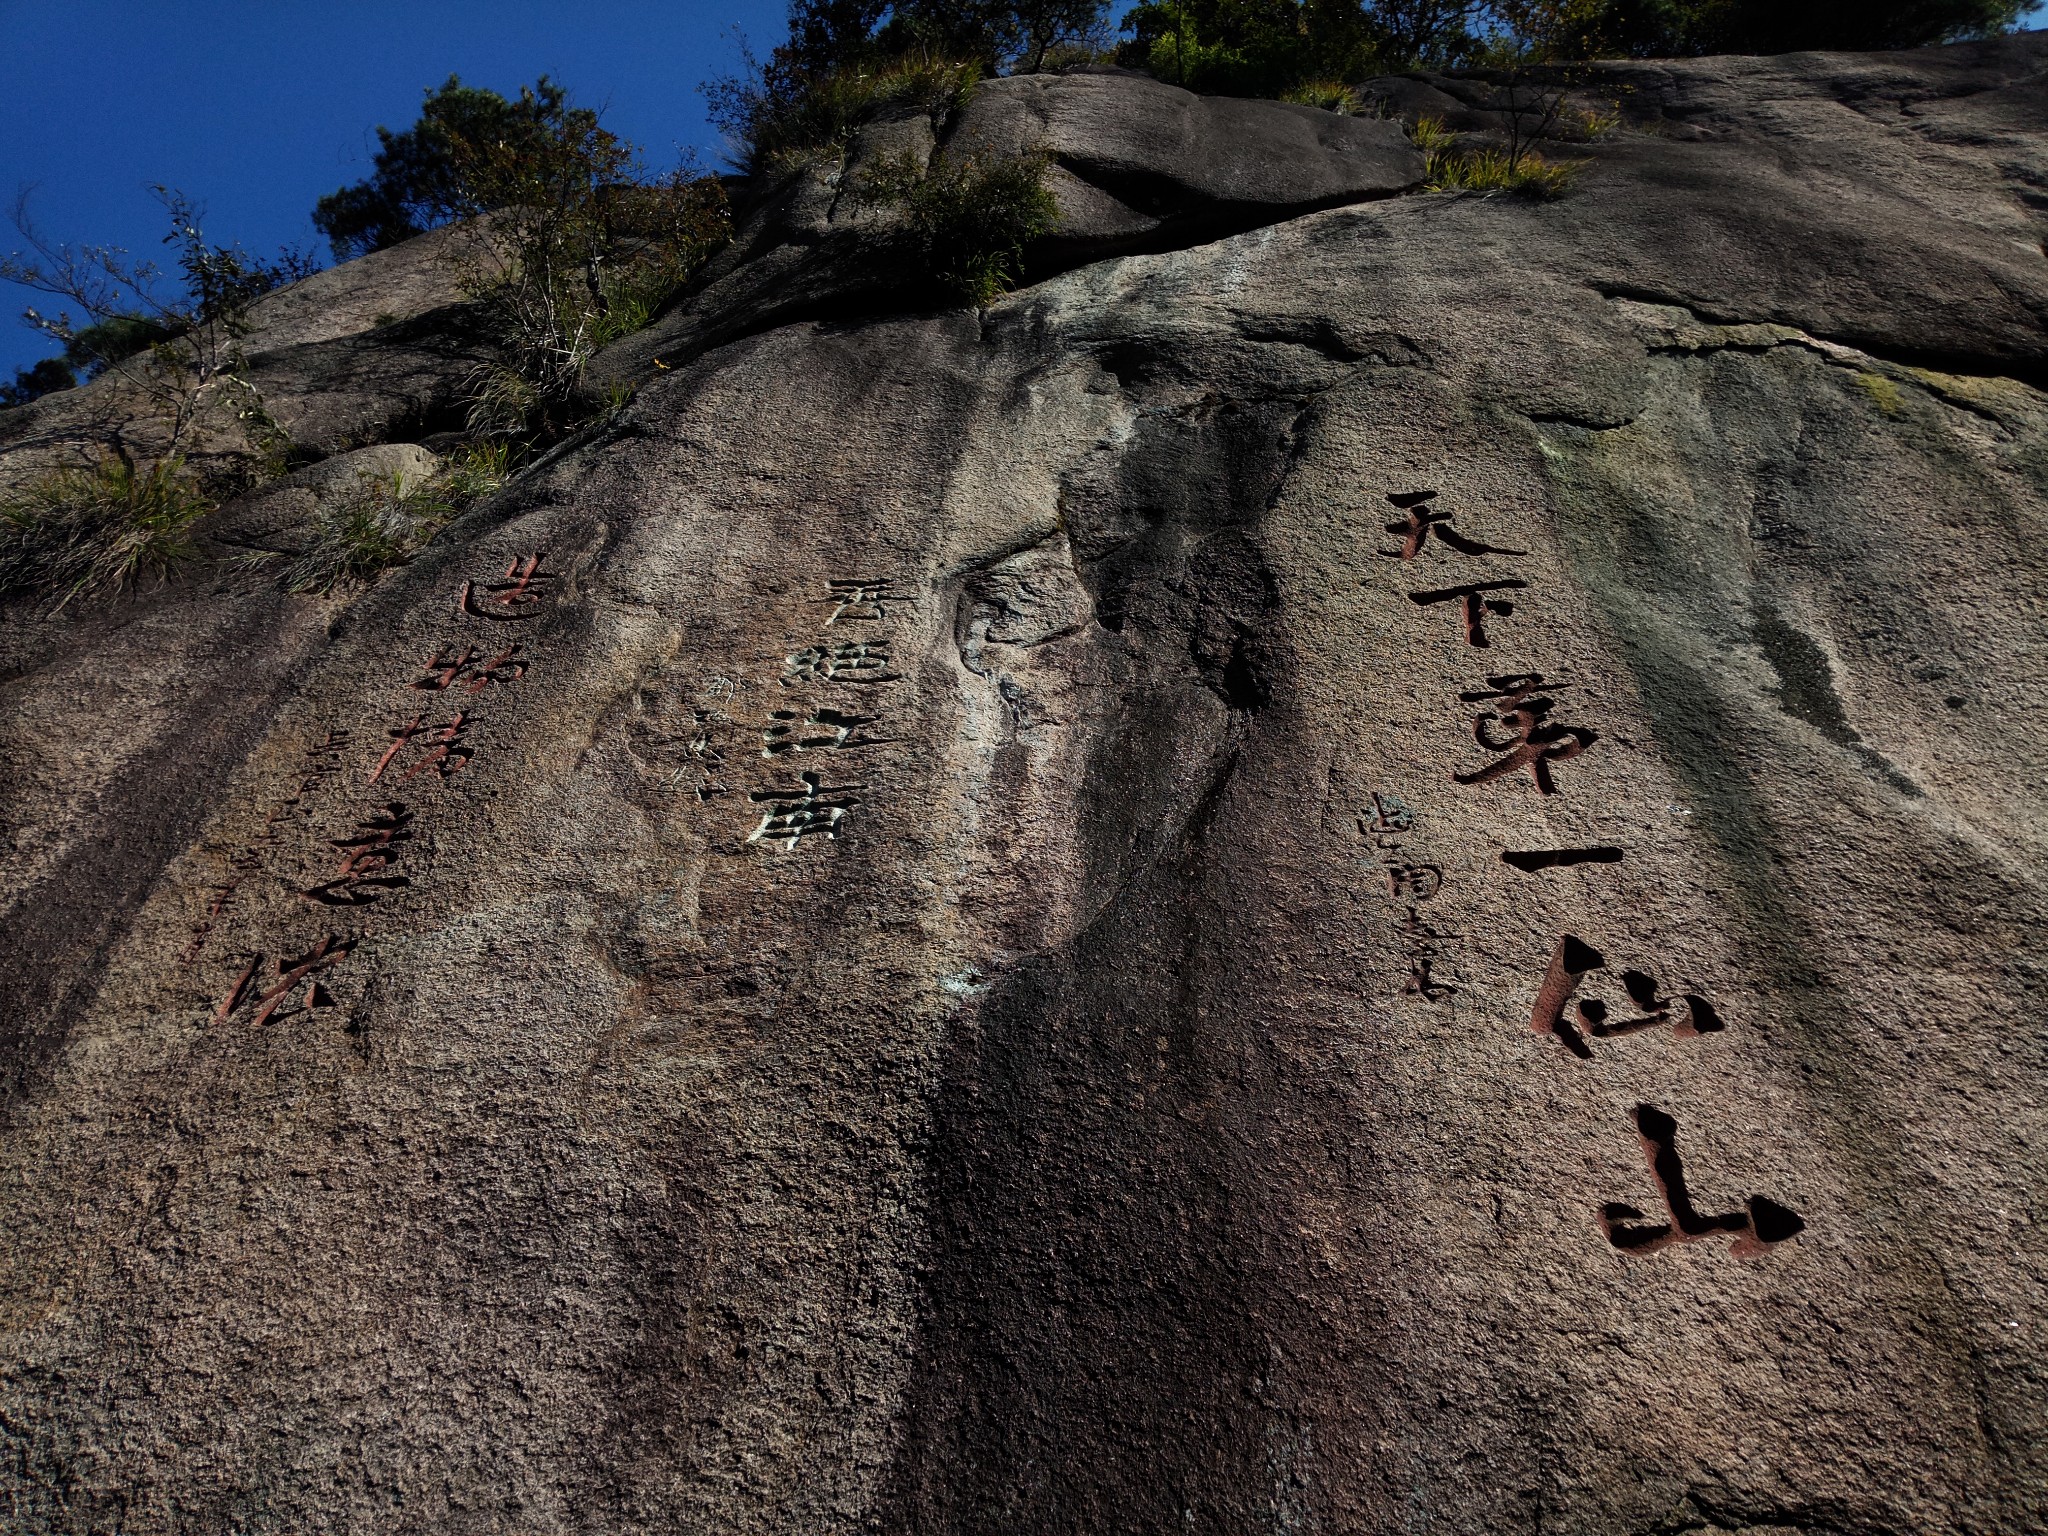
[[0, 0, 784, 377]]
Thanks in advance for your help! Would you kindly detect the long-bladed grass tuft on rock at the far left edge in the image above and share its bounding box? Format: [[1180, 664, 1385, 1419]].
[[0, 457, 213, 612]]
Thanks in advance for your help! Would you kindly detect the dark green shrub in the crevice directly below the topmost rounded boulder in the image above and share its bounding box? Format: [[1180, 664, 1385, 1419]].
[[856, 152, 1059, 307]]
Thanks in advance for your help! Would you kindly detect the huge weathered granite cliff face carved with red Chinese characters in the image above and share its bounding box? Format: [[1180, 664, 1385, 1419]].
[[0, 39, 2048, 1536]]
